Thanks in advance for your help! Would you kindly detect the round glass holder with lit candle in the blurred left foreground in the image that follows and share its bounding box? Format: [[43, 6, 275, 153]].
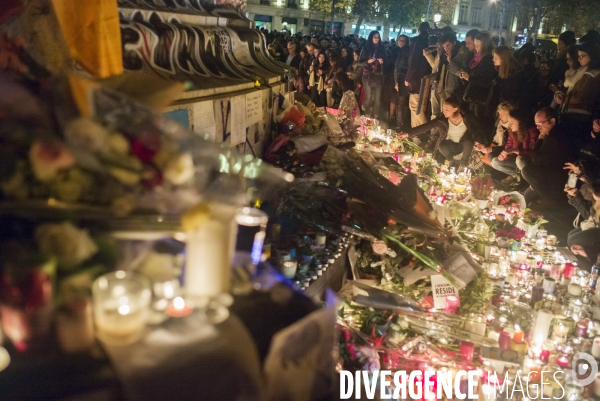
[[92, 270, 152, 346]]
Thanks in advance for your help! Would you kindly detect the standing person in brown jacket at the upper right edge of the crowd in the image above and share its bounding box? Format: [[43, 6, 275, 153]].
[[554, 42, 600, 148]]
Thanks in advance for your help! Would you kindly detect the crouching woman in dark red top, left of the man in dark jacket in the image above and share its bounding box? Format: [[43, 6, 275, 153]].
[[492, 109, 540, 185]]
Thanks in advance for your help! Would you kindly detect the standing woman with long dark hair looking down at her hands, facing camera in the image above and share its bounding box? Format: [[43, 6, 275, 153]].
[[358, 31, 386, 118]]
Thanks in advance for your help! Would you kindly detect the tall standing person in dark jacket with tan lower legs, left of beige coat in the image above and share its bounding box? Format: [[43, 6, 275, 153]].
[[404, 22, 431, 127]]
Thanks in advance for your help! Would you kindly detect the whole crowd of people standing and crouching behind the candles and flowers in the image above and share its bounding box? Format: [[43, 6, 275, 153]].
[[268, 22, 600, 263]]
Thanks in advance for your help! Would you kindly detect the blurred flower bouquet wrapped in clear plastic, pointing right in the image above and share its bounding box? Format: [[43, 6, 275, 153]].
[[0, 75, 287, 218]]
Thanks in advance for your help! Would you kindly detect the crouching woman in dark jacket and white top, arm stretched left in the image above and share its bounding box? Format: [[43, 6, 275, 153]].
[[398, 97, 480, 168]]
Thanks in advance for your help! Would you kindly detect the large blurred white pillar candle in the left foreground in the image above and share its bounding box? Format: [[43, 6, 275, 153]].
[[184, 203, 237, 299]]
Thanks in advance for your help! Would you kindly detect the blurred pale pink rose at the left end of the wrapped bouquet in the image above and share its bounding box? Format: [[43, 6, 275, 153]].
[[29, 141, 75, 181]]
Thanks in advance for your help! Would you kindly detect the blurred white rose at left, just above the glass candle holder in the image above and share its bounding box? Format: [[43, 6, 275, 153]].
[[35, 222, 98, 269]]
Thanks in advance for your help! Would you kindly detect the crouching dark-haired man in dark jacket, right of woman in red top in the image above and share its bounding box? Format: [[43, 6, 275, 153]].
[[517, 107, 576, 204]]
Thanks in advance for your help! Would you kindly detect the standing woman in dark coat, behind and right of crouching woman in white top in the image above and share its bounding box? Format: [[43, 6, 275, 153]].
[[460, 32, 498, 123]]
